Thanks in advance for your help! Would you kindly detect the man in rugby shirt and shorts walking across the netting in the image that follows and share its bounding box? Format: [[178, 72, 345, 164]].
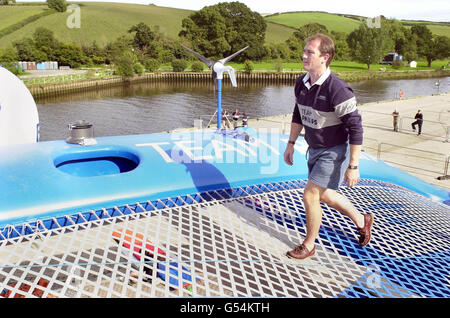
[[284, 34, 373, 259]]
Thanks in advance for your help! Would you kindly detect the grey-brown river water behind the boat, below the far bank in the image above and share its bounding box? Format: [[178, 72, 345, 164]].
[[36, 77, 450, 141]]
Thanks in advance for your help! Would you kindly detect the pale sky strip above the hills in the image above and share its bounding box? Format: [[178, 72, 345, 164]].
[[17, 0, 450, 22]]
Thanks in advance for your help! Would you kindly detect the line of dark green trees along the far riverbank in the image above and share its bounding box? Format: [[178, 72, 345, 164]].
[[0, 0, 450, 77]]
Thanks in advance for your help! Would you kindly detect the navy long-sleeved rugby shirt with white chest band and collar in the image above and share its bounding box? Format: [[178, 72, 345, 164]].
[[292, 68, 363, 148]]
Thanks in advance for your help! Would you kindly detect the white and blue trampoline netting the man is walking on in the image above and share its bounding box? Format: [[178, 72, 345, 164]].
[[0, 180, 450, 297]]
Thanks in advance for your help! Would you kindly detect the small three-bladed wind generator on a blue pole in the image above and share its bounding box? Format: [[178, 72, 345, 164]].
[[181, 44, 248, 131]]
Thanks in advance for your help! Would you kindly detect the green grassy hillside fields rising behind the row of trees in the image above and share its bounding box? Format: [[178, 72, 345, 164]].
[[0, 2, 450, 47]]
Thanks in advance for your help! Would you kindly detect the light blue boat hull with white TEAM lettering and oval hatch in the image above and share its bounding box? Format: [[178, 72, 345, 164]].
[[0, 129, 450, 226]]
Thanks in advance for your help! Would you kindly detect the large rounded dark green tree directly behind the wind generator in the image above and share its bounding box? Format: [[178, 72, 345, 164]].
[[179, 2, 267, 61]]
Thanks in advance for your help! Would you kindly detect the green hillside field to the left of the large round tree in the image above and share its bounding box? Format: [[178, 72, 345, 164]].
[[0, 2, 192, 47]]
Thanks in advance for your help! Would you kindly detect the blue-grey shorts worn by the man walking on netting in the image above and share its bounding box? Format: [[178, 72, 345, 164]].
[[308, 143, 350, 190]]
